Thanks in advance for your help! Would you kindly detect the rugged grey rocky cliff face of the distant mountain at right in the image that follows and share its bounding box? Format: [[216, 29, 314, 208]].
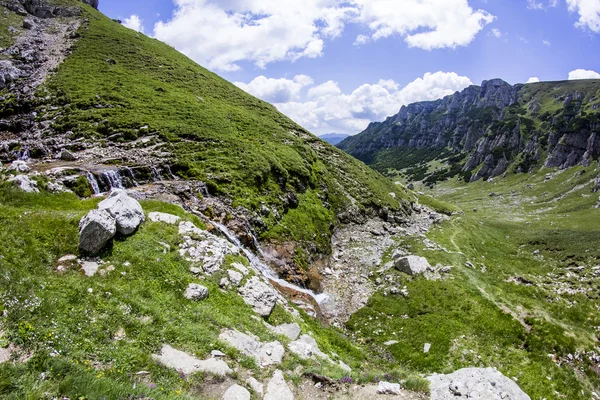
[[339, 79, 600, 181]]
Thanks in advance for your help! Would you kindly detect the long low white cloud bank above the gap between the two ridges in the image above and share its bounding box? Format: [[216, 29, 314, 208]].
[[237, 72, 472, 134]]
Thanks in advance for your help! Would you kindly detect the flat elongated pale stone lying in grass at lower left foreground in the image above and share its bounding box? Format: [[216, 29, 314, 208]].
[[152, 344, 233, 376]]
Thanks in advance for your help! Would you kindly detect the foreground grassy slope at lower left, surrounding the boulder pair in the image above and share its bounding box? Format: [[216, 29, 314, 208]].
[[0, 184, 432, 400]]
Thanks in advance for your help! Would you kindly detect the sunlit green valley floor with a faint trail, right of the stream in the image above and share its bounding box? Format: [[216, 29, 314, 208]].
[[348, 167, 600, 399]]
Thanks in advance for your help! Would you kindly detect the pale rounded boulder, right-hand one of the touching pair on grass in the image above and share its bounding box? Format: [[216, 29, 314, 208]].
[[98, 189, 145, 235]]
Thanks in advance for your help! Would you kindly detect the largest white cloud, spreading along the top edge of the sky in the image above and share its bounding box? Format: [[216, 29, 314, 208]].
[[154, 0, 495, 71]]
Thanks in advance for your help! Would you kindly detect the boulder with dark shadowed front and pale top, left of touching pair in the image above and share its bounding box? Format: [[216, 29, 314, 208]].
[[79, 210, 117, 255]]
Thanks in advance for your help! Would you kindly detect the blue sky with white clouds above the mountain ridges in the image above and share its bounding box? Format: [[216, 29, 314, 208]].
[[100, 0, 600, 134]]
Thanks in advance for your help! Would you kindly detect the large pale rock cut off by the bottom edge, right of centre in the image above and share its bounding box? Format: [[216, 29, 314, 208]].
[[427, 368, 531, 400]]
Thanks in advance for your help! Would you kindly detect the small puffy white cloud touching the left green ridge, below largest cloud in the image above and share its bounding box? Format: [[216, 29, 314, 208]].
[[235, 75, 314, 103]]
